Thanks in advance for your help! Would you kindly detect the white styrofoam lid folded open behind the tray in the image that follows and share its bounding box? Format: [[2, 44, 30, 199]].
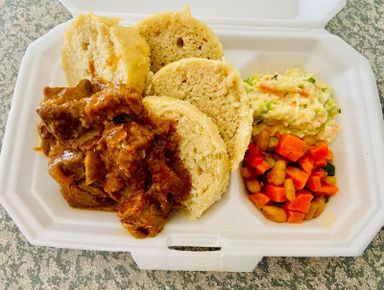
[[61, 0, 345, 28]]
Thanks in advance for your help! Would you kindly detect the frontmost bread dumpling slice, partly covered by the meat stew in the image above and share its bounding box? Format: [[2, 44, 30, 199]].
[[143, 96, 230, 219]]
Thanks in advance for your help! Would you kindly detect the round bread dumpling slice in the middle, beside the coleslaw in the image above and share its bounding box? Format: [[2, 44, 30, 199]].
[[147, 58, 253, 170]]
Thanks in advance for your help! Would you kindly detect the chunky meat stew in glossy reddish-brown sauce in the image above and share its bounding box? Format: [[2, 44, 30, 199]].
[[37, 80, 191, 238]]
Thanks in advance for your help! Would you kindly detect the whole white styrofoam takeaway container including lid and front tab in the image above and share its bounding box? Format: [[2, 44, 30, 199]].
[[0, 0, 384, 271]]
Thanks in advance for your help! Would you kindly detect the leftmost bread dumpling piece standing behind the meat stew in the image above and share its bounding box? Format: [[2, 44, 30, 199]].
[[62, 14, 150, 93]]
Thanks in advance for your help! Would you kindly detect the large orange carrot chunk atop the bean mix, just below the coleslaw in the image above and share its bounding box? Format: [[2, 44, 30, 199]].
[[275, 134, 308, 161]]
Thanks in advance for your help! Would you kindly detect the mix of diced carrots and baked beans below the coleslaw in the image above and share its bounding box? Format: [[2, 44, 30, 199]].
[[241, 127, 339, 223]]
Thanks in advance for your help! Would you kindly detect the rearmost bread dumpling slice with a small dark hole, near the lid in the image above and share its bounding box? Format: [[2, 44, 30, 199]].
[[137, 6, 224, 72]]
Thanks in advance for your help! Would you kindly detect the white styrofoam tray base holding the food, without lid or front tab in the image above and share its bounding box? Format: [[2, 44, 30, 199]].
[[0, 23, 384, 256]]
